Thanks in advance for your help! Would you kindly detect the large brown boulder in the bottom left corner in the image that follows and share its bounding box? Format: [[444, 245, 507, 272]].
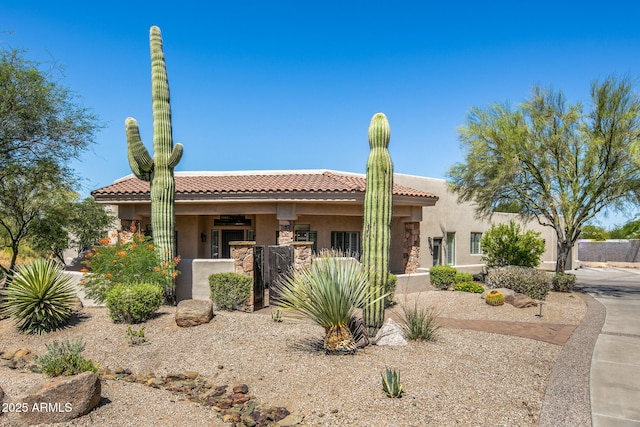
[[20, 372, 101, 425]]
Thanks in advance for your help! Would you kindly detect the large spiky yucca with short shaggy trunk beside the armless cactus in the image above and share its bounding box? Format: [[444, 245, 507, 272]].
[[275, 254, 386, 353]]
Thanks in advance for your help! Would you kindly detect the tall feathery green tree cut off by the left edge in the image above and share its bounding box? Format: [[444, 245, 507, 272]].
[[0, 50, 101, 271]]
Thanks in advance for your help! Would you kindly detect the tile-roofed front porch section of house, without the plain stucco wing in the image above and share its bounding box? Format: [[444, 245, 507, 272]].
[[91, 170, 438, 273]]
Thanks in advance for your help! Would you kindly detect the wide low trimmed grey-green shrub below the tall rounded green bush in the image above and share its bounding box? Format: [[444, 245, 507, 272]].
[[486, 267, 551, 299]]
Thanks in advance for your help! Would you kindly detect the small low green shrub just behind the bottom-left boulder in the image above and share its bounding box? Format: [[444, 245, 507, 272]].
[[34, 340, 98, 377]]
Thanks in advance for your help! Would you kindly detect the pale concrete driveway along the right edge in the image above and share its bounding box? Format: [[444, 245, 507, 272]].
[[572, 268, 640, 427]]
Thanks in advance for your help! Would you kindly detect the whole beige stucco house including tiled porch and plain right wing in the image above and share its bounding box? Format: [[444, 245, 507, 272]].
[[91, 170, 556, 273]]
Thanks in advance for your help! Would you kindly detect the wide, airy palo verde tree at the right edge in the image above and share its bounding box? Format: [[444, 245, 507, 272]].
[[448, 77, 640, 272]]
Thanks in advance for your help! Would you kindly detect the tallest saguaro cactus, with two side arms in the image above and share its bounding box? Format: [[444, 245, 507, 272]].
[[125, 26, 182, 302]]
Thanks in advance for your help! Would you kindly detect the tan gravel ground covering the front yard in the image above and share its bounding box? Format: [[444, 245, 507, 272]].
[[0, 291, 587, 426]]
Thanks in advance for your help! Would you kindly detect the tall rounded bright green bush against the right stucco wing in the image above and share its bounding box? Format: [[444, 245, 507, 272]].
[[480, 221, 545, 268]]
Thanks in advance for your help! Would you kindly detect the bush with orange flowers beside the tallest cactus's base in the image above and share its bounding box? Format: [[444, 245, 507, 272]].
[[82, 233, 180, 303]]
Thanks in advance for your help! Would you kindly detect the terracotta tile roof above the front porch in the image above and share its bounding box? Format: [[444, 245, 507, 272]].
[[91, 171, 437, 199]]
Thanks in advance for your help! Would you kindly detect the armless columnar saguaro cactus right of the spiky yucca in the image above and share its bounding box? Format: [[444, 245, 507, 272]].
[[362, 113, 393, 336]]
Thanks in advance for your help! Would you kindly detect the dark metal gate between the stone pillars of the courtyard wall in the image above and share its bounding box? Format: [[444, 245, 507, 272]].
[[253, 246, 294, 307]]
